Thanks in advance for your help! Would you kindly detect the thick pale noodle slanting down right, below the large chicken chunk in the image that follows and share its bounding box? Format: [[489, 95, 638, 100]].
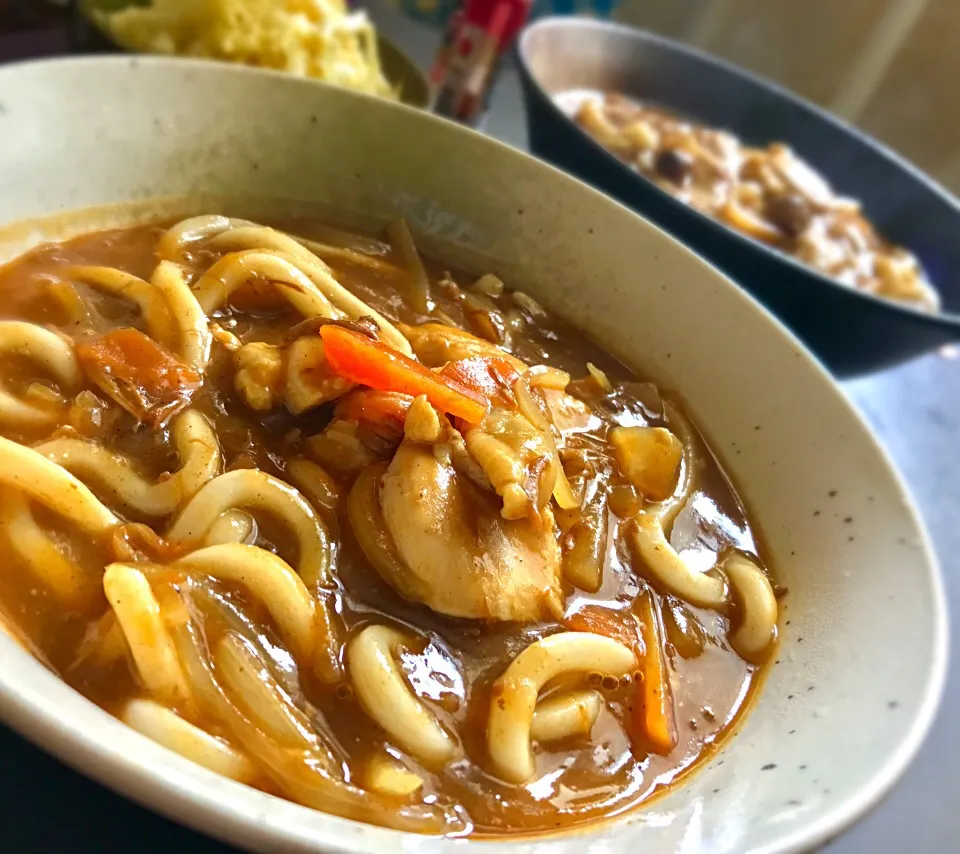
[[347, 626, 460, 765]]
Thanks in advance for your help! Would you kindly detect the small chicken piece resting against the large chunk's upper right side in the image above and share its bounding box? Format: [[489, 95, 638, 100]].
[[464, 408, 557, 521]]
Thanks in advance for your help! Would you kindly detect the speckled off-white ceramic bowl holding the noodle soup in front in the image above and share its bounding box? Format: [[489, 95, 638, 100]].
[[0, 58, 947, 854]]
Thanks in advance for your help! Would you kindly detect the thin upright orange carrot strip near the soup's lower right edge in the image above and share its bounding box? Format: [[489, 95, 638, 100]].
[[633, 591, 679, 756]]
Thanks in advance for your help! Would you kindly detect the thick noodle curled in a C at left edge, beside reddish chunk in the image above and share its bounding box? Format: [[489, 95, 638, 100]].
[[0, 320, 82, 428]]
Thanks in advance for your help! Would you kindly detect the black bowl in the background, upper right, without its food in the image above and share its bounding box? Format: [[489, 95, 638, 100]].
[[519, 18, 960, 376]]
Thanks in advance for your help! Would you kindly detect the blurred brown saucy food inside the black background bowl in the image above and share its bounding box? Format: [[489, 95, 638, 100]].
[[557, 91, 940, 311]]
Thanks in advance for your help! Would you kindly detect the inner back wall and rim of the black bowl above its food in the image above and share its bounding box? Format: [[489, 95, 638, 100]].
[[521, 19, 960, 320]]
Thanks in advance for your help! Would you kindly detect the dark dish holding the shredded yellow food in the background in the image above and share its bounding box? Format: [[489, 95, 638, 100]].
[[69, 0, 430, 109]]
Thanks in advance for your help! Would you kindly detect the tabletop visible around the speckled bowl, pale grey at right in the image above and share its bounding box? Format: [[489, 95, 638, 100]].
[[0, 8, 960, 854]]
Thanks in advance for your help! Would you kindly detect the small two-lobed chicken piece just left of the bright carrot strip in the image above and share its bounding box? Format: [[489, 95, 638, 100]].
[[234, 335, 352, 415]]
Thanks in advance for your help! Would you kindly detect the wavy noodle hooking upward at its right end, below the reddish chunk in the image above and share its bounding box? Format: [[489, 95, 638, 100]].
[[34, 410, 222, 516]]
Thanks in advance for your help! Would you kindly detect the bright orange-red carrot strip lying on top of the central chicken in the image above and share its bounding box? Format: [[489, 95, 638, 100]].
[[320, 325, 490, 424]]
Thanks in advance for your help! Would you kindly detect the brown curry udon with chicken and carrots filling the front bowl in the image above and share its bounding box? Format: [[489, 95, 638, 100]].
[[0, 217, 776, 835]]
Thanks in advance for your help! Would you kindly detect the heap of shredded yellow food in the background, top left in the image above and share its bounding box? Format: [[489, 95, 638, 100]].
[[101, 0, 396, 97]]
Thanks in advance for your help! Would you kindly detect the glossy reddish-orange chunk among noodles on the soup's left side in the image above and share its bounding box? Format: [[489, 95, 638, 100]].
[[77, 328, 203, 427]]
